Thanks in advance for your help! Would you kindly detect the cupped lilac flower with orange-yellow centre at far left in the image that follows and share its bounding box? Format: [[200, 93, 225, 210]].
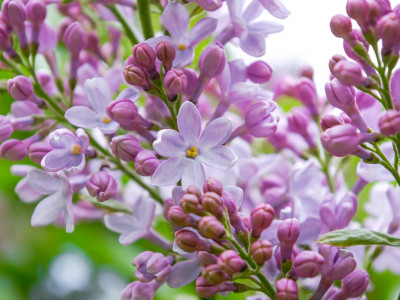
[[41, 128, 89, 172]]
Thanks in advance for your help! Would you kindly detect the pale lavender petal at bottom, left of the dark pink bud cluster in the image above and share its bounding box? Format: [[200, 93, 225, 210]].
[[167, 260, 201, 289]]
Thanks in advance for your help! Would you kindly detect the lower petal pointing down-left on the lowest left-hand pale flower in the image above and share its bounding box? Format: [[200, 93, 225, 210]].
[[31, 191, 65, 227]]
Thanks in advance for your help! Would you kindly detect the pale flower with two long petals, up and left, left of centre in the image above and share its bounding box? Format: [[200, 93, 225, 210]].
[[65, 77, 119, 134]]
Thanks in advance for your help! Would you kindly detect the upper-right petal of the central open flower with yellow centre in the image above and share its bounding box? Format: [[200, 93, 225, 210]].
[[199, 117, 232, 149]]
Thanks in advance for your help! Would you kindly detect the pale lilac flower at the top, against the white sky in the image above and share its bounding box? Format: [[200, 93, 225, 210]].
[[216, 0, 283, 57]]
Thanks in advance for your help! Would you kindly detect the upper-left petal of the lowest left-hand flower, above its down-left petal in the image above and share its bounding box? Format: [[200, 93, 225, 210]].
[[27, 169, 63, 195]]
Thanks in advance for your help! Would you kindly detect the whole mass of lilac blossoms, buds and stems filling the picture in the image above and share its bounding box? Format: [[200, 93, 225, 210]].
[[0, 0, 400, 300]]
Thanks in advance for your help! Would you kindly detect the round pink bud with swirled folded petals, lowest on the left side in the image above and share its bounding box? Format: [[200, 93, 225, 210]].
[[86, 171, 117, 202]]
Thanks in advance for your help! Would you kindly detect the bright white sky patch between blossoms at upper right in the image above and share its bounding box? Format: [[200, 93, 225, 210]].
[[228, 0, 400, 93]]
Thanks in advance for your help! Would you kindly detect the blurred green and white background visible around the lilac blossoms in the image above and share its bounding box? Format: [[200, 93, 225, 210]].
[[0, 0, 400, 300]]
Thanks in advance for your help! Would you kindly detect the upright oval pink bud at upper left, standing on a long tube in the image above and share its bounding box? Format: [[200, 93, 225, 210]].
[[63, 22, 87, 58]]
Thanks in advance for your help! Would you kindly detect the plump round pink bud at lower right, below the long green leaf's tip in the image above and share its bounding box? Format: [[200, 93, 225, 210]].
[[293, 251, 325, 278]]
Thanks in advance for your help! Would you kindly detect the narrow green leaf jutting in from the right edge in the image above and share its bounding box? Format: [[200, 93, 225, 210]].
[[316, 229, 400, 247]]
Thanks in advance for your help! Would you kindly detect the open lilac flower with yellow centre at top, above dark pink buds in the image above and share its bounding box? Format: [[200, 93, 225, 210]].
[[146, 2, 217, 69]]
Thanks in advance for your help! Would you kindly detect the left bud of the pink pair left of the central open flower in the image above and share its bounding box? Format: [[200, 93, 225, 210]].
[[110, 134, 143, 162]]
